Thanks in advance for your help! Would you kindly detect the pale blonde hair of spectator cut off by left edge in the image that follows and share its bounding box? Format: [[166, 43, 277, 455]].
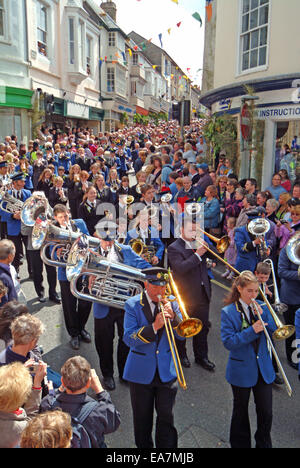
[[0, 362, 32, 413]]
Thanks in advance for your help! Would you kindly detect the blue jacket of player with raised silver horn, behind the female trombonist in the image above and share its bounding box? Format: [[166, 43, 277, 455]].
[[234, 226, 268, 273]]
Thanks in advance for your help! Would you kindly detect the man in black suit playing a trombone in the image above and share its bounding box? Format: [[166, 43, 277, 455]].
[[168, 217, 215, 371]]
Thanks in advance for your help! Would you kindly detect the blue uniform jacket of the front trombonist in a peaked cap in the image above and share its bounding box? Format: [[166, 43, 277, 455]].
[[123, 294, 182, 384]]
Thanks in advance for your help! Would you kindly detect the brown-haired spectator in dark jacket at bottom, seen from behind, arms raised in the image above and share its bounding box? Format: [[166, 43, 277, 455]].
[[41, 356, 120, 448]]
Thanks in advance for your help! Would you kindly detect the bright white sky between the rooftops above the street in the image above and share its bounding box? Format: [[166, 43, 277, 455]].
[[114, 0, 205, 87]]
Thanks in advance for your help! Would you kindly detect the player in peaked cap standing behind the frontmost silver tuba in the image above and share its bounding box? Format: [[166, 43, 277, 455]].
[[93, 220, 150, 390]]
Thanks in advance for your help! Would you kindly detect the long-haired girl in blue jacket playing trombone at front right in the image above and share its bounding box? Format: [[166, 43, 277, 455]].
[[221, 271, 277, 448]]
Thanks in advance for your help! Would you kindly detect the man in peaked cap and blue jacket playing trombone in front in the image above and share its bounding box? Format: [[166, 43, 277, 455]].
[[124, 268, 184, 449]]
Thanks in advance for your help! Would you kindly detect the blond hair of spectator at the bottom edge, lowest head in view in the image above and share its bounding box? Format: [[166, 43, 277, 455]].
[[20, 409, 72, 448]]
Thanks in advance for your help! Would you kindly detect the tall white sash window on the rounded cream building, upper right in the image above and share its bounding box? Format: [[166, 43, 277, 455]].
[[236, 0, 272, 77]]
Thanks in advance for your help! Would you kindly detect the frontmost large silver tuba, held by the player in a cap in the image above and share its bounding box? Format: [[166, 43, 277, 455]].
[[66, 237, 146, 309]]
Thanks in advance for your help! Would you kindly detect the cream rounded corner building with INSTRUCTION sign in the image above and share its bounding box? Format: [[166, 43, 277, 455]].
[[201, 0, 300, 187]]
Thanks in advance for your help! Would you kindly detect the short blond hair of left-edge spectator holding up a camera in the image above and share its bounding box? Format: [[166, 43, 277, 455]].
[[10, 314, 45, 346]]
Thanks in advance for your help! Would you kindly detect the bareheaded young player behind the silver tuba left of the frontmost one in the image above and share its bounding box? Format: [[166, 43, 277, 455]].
[[53, 205, 92, 350]]
